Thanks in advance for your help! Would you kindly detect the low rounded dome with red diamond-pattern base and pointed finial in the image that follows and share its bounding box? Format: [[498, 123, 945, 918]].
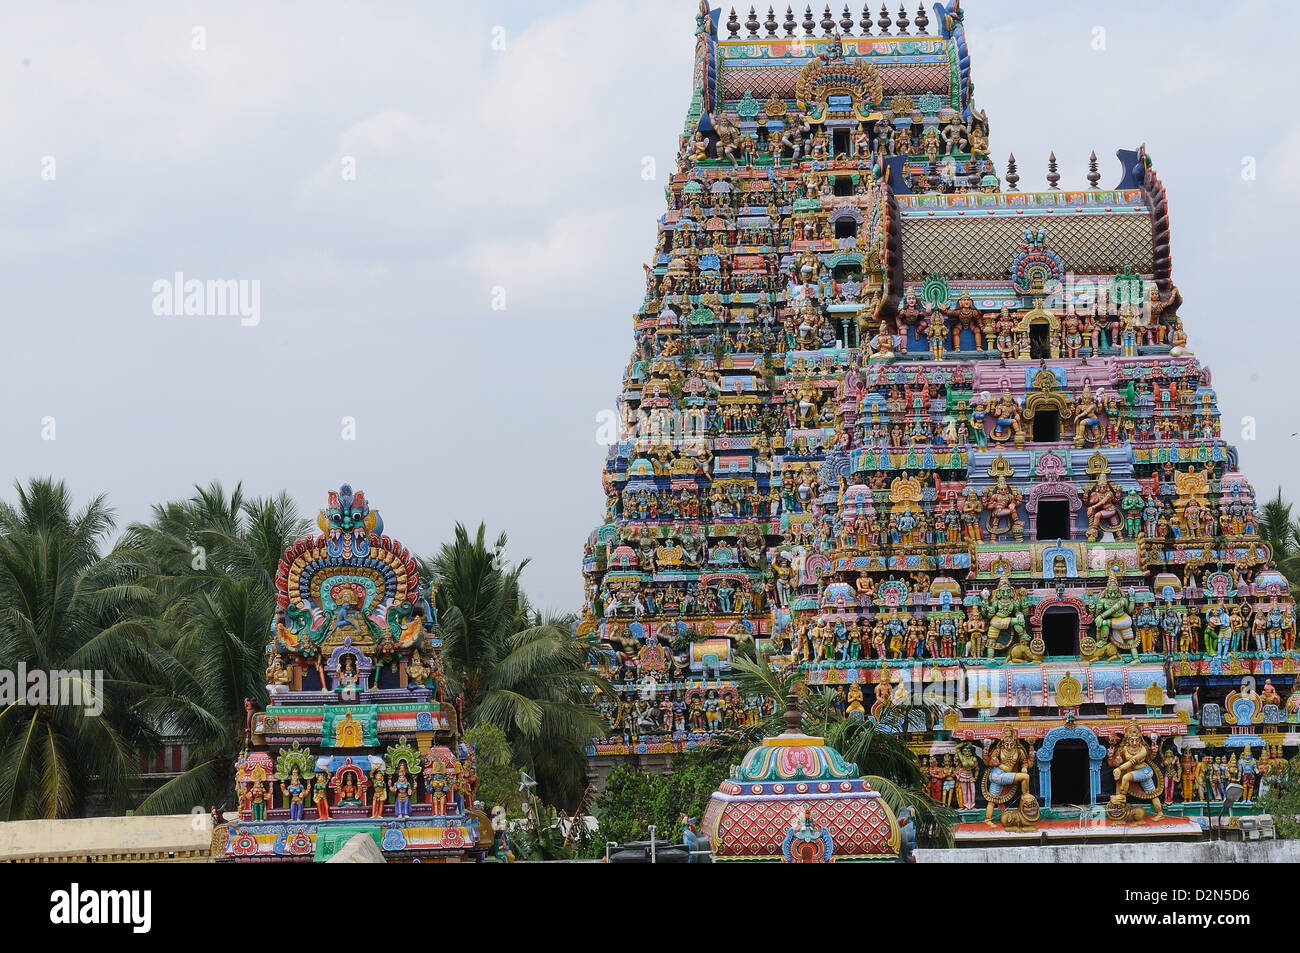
[[703, 692, 900, 863]]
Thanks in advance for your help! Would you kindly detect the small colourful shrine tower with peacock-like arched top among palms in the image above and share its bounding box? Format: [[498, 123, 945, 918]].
[[213, 484, 493, 861]]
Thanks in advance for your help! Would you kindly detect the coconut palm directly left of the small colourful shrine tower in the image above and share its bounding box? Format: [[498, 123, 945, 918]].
[[127, 484, 307, 813]]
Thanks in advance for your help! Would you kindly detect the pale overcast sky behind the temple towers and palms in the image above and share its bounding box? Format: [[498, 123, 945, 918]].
[[0, 0, 1300, 610]]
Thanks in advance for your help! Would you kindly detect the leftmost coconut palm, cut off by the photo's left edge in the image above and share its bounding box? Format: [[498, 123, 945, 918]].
[[0, 478, 168, 820]]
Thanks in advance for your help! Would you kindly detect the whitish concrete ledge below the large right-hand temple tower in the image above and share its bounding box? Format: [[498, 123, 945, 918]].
[[917, 840, 1300, 863]]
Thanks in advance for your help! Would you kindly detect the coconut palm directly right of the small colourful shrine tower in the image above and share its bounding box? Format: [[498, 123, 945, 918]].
[[430, 524, 614, 803]]
